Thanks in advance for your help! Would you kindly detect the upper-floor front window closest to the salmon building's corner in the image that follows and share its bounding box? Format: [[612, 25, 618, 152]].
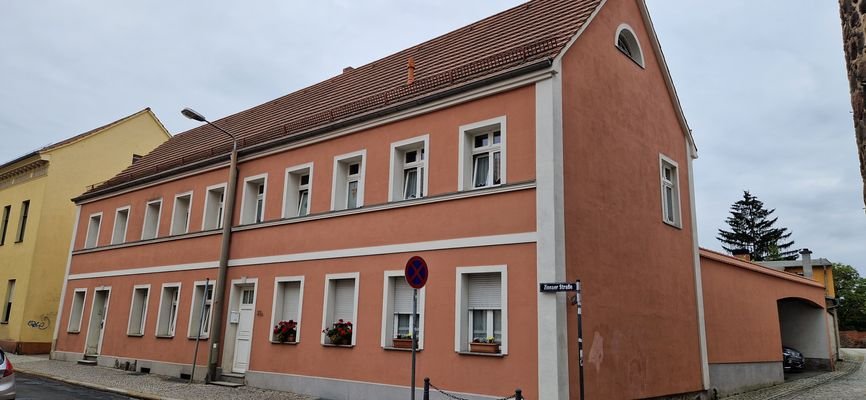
[[458, 117, 506, 190]]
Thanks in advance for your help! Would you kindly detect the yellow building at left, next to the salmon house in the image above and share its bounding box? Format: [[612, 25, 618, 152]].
[[0, 108, 171, 354]]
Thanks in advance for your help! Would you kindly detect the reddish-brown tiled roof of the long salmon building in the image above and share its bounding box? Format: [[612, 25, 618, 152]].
[[86, 0, 601, 200]]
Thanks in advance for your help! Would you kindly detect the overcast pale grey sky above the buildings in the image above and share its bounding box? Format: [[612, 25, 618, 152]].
[[0, 0, 866, 274]]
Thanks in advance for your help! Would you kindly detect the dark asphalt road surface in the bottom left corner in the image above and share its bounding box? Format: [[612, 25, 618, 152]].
[[15, 372, 133, 400]]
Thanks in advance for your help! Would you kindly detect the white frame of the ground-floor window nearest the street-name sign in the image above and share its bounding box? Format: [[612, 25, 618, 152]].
[[454, 265, 508, 355]]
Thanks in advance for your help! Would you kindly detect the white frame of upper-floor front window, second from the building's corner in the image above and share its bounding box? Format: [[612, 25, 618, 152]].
[[388, 135, 430, 201]]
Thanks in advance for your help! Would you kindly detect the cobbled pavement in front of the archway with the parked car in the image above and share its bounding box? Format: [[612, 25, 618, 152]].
[[724, 349, 866, 400]]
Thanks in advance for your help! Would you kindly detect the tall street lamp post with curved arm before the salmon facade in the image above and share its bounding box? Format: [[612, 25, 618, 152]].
[[180, 108, 238, 382]]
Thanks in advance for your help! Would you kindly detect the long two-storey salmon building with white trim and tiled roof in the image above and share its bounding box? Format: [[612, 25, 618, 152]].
[[52, 0, 709, 399]]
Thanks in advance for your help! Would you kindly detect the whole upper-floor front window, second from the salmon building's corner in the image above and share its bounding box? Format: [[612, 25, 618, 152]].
[[388, 135, 428, 201]]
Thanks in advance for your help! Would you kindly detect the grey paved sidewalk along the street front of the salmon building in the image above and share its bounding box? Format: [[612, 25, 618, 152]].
[[7, 354, 314, 400]]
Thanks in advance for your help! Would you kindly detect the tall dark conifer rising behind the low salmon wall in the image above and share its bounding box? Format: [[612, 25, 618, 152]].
[[716, 190, 797, 261]]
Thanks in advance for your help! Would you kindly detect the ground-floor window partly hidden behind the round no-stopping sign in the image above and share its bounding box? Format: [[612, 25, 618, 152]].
[[382, 271, 425, 348]]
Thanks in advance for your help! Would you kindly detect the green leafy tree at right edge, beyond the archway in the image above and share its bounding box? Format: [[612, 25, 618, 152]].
[[833, 263, 866, 331]]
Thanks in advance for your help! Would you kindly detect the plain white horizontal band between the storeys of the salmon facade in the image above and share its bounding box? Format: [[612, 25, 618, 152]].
[[68, 232, 536, 280]]
